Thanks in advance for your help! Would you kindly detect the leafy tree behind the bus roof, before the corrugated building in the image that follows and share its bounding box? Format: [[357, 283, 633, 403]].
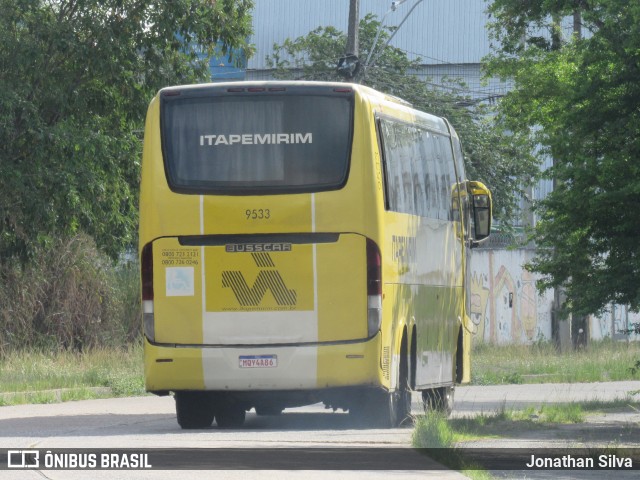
[[267, 15, 537, 227]]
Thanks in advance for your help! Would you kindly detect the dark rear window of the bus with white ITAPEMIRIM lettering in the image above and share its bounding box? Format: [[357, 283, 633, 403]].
[[161, 94, 353, 195]]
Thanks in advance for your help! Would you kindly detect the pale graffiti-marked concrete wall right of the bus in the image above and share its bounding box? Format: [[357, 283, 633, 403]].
[[470, 248, 640, 344]]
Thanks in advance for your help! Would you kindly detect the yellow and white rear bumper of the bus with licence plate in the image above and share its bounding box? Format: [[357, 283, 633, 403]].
[[144, 335, 382, 392]]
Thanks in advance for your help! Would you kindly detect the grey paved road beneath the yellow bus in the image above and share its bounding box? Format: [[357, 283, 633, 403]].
[[0, 382, 640, 480]]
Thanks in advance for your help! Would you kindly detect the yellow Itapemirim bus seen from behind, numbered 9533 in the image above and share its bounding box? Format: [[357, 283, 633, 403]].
[[139, 82, 491, 428]]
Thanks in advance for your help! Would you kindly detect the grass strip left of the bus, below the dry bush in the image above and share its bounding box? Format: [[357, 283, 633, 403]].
[[0, 345, 144, 405]]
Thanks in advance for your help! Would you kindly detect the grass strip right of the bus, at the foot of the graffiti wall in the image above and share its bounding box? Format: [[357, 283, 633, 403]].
[[471, 341, 640, 385]]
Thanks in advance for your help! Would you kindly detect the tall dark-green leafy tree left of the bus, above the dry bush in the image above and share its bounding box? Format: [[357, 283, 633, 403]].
[[0, 0, 253, 258]]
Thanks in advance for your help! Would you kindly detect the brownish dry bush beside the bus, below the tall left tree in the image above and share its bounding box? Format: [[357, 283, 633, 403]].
[[0, 234, 141, 357]]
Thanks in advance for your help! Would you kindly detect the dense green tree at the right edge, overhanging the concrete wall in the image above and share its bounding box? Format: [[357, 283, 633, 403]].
[[488, 0, 640, 315]]
